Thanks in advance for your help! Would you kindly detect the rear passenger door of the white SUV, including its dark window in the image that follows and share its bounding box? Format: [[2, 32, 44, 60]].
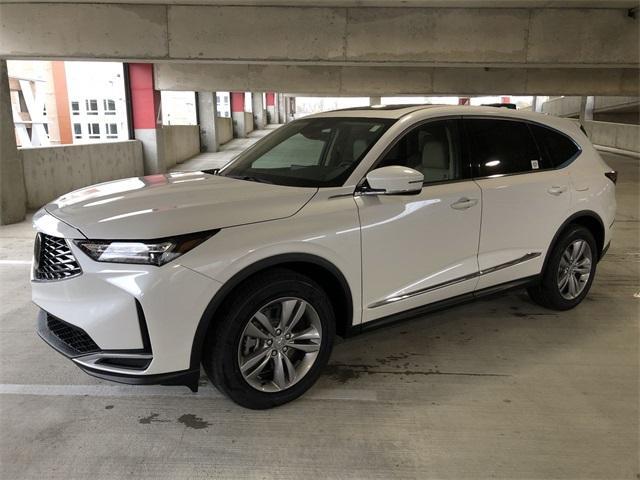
[[464, 118, 570, 290]]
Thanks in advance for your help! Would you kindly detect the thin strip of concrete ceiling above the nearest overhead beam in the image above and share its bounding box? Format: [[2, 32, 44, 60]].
[[0, 0, 638, 9]]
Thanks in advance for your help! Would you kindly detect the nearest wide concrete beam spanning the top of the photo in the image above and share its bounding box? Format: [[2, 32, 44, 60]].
[[0, 3, 640, 68]]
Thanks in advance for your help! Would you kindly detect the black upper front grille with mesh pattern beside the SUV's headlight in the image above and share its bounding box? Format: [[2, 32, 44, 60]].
[[34, 233, 82, 281]]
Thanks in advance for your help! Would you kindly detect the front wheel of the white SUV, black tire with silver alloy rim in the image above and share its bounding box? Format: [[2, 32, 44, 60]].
[[202, 268, 335, 410]]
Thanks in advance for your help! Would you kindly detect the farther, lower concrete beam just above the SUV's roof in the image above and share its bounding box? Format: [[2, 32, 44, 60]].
[[155, 63, 640, 96]]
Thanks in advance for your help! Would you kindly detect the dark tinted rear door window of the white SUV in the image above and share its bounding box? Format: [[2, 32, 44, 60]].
[[465, 119, 545, 177]]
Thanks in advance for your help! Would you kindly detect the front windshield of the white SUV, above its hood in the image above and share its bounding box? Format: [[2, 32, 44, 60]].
[[220, 117, 394, 187]]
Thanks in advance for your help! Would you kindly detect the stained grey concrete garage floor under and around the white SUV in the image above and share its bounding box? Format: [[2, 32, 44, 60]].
[[0, 155, 640, 479]]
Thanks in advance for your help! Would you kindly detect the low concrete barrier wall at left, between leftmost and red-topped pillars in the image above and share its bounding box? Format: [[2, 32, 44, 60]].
[[20, 140, 144, 210]]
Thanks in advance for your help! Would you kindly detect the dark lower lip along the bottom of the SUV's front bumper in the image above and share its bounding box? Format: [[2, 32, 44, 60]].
[[37, 309, 200, 392]]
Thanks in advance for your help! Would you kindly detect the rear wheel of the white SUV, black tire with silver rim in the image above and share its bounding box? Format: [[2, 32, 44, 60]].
[[527, 224, 598, 310]]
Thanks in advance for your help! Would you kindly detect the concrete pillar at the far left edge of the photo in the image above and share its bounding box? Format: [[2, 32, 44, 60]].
[[0, 60, 27, 225]]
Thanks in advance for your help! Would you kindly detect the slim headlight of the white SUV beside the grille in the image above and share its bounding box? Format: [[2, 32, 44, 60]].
[[75, 230, 219, 267]]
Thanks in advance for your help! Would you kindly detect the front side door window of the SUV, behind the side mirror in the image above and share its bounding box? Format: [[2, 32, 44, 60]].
[[376, 120, 466, 183]]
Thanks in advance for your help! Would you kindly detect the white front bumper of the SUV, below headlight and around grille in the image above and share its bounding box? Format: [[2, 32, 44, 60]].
[[31, 213, 221, 386]]
